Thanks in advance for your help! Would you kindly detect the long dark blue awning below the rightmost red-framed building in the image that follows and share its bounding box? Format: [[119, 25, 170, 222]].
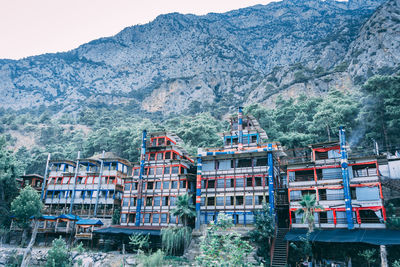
[[285, 229, 400, 245]]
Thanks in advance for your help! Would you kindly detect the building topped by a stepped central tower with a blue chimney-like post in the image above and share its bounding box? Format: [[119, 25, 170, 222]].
[[196, 108, 282, 227]]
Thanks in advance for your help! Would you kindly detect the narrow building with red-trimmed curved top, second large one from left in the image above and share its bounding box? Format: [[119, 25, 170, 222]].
[[121, 131, 195, 227]]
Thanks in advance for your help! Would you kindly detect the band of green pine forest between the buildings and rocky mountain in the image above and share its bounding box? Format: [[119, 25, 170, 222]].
[[0, 76, 400, 176]]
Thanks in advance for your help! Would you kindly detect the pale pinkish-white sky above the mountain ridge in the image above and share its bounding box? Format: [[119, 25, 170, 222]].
[[0, 0, 273, 59]]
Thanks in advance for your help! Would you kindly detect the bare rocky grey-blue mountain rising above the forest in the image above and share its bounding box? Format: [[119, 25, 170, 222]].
[[0, 0, 400, 115]]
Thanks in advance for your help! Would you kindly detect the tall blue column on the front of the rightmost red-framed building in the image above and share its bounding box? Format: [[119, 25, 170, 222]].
[[339, 126, 354, 230]]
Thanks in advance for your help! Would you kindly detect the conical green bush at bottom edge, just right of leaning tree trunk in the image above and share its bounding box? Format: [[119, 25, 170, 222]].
[[45, 239, 71, 267]]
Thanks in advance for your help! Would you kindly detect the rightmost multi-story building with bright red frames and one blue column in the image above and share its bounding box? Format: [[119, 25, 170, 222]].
[[287, 129, 386, 229]]
